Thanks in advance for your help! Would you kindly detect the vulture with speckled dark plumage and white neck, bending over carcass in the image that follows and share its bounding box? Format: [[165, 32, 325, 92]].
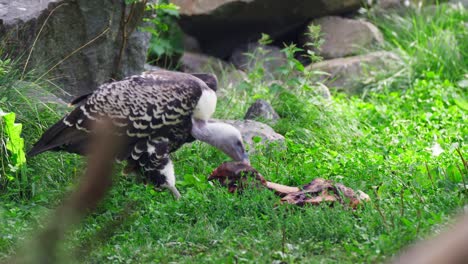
[[27, 70, 249, 199]]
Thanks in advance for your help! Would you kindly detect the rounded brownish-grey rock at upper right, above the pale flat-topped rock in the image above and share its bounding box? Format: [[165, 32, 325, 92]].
[[303, 16, 383, 59]]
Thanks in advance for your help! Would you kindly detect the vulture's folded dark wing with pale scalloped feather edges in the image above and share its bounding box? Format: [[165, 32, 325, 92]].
[[29, 71, 209, 156]]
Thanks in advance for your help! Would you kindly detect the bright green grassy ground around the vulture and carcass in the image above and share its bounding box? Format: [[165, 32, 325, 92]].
[[0, 2, 468, 263]]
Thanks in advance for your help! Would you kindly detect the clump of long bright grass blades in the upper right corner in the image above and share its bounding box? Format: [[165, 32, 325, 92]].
[[369, 4, 468, 81]]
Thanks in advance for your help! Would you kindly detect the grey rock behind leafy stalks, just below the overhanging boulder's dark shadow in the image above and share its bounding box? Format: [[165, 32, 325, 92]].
[[229, 43, 287, 79]]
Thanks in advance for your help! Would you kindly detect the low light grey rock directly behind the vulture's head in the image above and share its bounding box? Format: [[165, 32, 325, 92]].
[[221, 120, 284, 150]]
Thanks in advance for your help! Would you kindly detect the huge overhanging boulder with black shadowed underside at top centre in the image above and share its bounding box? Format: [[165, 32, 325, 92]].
[[171, 0, 361, 58]]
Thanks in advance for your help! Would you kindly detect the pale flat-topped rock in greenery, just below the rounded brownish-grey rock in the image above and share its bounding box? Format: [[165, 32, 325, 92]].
[[308, 51, 401, 94]]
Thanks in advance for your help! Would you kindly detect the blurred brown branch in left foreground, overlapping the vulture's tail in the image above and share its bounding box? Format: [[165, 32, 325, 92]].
[[11, 121, 122, 263]]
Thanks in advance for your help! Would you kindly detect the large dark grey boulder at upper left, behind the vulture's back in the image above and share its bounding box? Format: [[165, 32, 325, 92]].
[[0, 0, 150, 97]]
